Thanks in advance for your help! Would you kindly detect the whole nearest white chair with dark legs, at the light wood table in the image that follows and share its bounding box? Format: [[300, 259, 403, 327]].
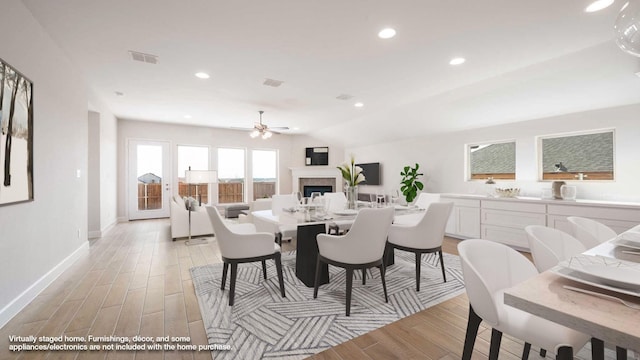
[[458, 239, 599, 360]]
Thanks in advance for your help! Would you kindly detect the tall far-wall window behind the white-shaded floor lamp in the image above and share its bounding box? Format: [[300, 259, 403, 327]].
[[178, 145, 209, 204]]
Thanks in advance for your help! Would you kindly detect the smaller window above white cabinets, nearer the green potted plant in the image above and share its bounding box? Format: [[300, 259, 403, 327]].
[[468, 141, 516, 180]]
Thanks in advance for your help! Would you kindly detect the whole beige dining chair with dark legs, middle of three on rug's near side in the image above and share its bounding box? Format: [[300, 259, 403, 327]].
[[313, 207, 394, 316]]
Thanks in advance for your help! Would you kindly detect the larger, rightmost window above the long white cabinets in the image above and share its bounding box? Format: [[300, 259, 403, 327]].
[[538, 130, 614, 180]]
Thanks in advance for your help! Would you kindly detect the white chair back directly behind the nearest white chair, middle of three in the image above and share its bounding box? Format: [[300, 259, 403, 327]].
[[525, 225, 586, 272]]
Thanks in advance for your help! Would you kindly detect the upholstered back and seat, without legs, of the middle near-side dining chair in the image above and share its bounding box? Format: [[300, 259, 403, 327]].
[[318, 207, 394, 264]]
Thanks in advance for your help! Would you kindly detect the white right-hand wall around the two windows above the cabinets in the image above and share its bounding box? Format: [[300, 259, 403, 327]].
[[346, 105, 640, 202]]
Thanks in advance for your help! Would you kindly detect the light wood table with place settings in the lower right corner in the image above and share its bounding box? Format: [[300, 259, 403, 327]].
[[504, 232, 640, 352]]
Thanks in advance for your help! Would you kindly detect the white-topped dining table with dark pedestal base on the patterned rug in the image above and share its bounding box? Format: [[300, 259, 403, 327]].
[[252, 205, 425, 287]]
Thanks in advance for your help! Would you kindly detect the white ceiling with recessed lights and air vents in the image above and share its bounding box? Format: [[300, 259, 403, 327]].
[[22, 0, 640, 146]]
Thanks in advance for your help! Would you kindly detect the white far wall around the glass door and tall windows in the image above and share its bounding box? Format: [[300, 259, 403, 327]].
[[117, 120, 343, 221]]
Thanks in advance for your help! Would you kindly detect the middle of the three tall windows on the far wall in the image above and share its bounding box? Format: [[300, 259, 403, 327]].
[[218, 148, 245, 204]]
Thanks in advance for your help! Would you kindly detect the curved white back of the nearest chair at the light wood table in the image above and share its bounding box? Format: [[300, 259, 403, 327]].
[[458, 239, 538, 327]]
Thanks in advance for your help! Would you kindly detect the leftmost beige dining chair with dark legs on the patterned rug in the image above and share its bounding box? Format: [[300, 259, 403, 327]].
[[207, 206, 286, 306]]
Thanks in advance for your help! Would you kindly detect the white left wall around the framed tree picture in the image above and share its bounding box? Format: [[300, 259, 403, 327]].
[[0, 1, 88, 326]]
